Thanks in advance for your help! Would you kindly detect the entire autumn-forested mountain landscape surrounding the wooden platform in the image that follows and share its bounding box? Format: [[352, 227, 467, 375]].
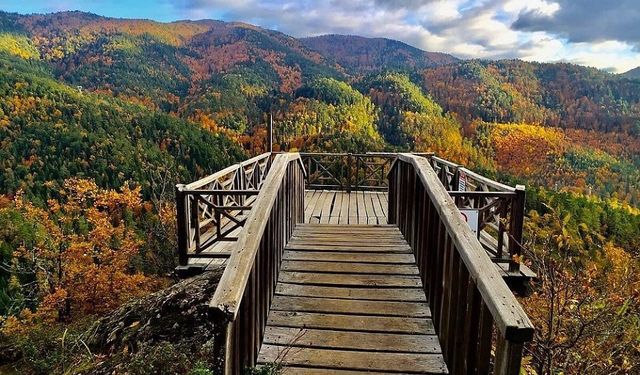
[[0, 12, 640, 373]]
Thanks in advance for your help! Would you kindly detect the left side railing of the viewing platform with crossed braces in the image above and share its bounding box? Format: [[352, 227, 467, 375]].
[[176, 153, 271, 266]]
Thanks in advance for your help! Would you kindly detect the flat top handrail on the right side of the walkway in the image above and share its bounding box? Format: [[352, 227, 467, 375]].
[[398, 153, 534, 342]]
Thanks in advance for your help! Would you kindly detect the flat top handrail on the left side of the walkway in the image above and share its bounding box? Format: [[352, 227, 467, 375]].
[[209, 153, 304, 321]]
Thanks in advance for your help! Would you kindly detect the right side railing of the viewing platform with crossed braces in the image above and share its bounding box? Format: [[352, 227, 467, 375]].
[[429, 156, 525, 272]]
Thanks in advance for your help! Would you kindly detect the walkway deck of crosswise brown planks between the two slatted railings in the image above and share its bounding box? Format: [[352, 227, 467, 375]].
[[258, 225, 447, 374]]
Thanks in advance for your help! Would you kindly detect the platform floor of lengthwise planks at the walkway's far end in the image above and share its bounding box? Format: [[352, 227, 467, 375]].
[[304, 190, 388, 225]]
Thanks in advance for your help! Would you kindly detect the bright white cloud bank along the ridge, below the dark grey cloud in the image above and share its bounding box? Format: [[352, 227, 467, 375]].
[[172, 0, 640, 71]]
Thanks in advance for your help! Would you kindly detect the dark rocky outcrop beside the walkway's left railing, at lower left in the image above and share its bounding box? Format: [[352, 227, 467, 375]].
[[84, 269, 224, 374]]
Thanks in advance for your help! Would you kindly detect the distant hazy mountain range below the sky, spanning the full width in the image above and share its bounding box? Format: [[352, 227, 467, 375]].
[[0, 12, 640, 138]]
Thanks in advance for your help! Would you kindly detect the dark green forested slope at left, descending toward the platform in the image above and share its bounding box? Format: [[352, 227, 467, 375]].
[[0, 53, 243, 201]]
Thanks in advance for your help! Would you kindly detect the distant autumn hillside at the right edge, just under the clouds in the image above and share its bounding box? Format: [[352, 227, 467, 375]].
[[422, 60, 640, 134]]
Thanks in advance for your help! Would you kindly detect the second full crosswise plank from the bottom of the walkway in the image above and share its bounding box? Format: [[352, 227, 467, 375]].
[[264, 327, 440, 354]]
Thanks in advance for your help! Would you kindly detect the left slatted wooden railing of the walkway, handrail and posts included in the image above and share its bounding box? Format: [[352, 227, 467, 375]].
[[210, 154, 305, 374]]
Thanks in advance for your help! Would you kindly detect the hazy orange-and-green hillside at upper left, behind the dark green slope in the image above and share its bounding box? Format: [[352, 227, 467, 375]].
[[0, 12, 340, 111]]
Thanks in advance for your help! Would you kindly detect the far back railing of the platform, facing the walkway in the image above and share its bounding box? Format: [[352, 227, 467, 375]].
[[300, 152, 396, 191]]
